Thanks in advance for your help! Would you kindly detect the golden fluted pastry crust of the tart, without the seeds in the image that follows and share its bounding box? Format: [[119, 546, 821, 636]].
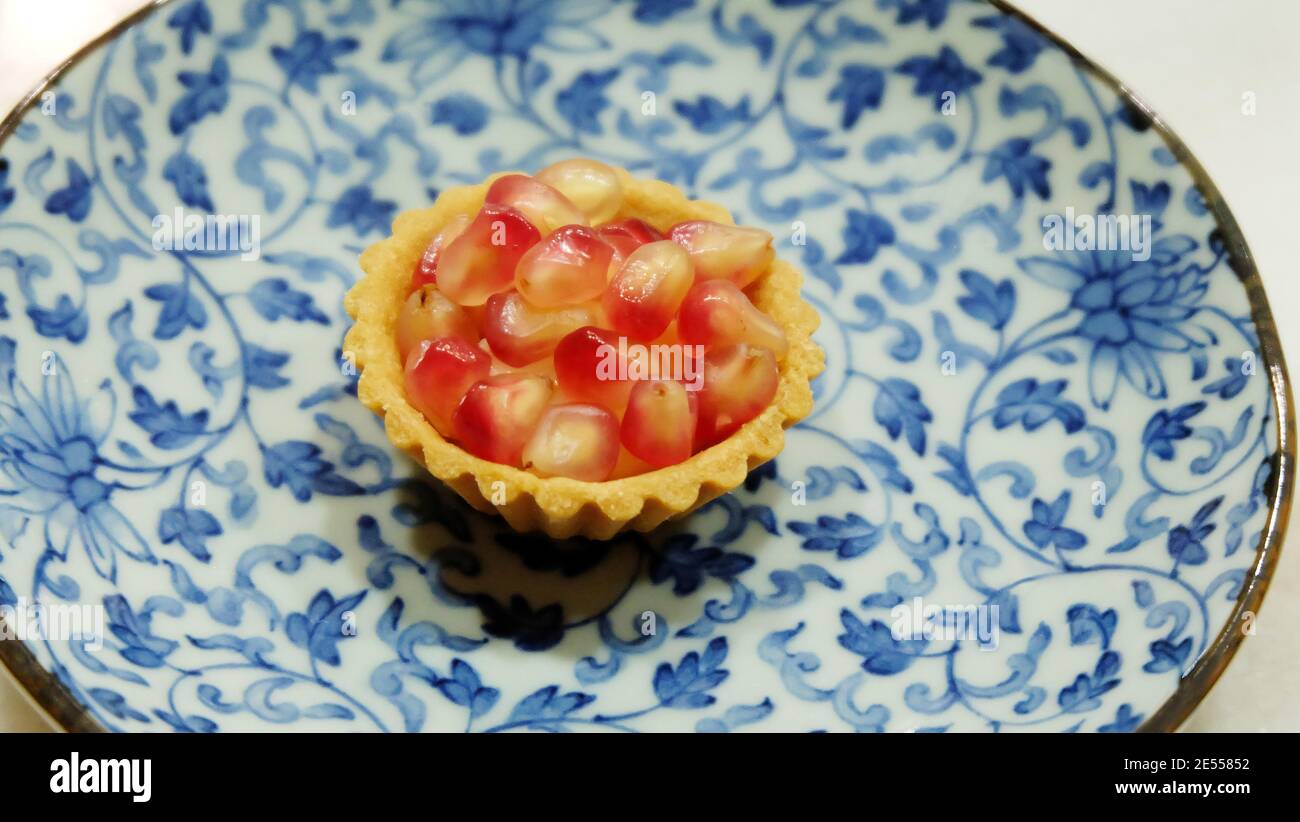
[[343, 169, 824, 540]]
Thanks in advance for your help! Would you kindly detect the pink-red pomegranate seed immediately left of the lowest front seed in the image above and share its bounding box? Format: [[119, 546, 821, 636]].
[[451, 373, 551, 467]]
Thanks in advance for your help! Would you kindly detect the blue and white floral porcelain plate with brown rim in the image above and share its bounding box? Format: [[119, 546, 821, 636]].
[[0, 0, 1295, 731]]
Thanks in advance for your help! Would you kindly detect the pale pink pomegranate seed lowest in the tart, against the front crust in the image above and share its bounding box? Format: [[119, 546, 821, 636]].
[[523, 403, 619, 483]]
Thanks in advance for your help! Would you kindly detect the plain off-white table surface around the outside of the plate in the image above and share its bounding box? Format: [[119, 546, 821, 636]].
[[0, 0, 1300, 732]]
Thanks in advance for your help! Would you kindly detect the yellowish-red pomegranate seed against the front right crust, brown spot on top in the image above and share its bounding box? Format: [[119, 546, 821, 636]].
[[696, 342, 781, 447]]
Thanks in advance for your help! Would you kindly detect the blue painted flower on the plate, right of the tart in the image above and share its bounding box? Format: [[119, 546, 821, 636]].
[[1019, 235, 1212, 408]]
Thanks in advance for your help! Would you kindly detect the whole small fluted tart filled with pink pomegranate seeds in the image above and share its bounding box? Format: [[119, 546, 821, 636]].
[[345, 160, 823, 538]]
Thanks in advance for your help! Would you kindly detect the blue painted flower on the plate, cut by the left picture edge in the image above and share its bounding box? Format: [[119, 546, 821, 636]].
[[0, 337, 155, 580]]
